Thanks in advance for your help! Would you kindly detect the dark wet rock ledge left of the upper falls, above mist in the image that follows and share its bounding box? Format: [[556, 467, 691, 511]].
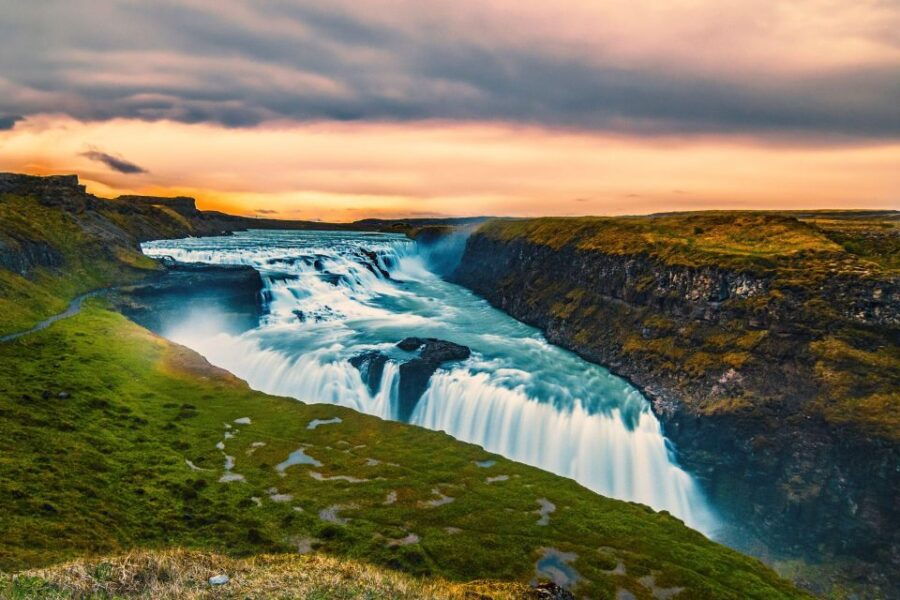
[[114, 261, 263, 333]]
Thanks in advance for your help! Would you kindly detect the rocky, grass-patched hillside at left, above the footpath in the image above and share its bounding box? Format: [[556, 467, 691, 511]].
[[0, 173, 344, 333]]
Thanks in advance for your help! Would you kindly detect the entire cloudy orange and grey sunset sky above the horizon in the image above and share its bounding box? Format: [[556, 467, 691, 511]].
[[0, 0, 900, 220]]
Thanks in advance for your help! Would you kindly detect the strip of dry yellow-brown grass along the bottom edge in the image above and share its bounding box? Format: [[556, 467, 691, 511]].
[[0, 549, 529, 600]]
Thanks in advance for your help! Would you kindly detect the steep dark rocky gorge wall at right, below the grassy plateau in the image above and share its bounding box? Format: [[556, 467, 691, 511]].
[[452, 219, 900, 588]]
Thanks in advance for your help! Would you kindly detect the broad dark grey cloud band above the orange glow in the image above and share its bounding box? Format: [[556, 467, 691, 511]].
[[0, 0, 900, 142]]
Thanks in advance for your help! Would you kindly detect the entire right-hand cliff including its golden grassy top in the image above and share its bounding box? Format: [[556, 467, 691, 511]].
[[453, 213, 900, 587]]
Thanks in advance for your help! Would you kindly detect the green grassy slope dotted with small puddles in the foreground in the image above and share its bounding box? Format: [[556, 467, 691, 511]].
[[0, 301, 802, 599]]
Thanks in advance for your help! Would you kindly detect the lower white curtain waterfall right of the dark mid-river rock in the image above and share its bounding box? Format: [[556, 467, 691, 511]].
[[410, 369, 711, 527]]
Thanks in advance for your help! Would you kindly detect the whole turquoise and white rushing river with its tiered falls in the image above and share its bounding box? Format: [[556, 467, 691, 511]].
[[144, 231, 715, 533]]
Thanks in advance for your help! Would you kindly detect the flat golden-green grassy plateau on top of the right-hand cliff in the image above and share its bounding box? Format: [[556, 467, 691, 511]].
[[478, 211, 900, 281]]
